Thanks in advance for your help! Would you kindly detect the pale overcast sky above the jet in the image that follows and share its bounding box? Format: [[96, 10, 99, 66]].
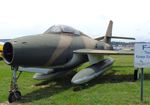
[[0, 0, 150, 41]]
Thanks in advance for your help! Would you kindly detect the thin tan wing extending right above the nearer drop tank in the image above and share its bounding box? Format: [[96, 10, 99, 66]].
[[74, 49, 134, 55]]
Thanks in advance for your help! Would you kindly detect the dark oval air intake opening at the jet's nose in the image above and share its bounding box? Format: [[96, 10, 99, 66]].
[[3, 42, 14, 64]]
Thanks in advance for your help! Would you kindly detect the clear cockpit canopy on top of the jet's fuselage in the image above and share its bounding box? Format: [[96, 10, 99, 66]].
[[44, 25, 82, 35]]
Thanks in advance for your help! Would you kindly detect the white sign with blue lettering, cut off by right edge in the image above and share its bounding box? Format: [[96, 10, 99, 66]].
[[134, 43, 150, 68]]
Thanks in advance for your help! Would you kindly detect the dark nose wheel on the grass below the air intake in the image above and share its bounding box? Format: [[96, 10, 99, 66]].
[[8, 91, 21, 103]]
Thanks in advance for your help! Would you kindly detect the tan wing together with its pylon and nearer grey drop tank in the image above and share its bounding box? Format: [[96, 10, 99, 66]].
[[71, 49, 134, 84]]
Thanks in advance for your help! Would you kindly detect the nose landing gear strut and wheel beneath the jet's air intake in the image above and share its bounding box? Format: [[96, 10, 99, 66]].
[[8, 66, 22, 103]]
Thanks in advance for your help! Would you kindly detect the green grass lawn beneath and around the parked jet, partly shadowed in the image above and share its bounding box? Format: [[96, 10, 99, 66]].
[[0, 56, 150, 105]]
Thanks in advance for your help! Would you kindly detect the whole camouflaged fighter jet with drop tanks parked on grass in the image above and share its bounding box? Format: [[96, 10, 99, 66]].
[[3, 21, 134, 103]]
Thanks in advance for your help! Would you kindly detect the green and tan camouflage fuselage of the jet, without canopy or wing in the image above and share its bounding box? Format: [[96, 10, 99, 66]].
[[3, 33, 97, 67]]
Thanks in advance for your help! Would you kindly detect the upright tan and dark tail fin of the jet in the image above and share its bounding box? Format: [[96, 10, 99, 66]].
[[104, 20, 113, 44]]
